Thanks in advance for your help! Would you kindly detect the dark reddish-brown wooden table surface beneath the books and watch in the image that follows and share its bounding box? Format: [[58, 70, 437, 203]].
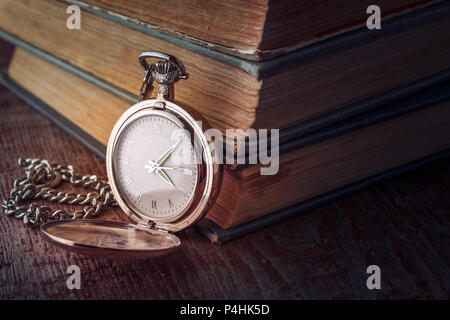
[[0, 51, 450, 299]]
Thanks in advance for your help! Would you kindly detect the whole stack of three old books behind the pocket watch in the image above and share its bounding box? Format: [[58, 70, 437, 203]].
[[0, 0, 450, 242]]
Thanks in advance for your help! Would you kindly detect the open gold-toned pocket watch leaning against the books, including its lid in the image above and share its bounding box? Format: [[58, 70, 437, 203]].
[[35, 52, 222, 258]]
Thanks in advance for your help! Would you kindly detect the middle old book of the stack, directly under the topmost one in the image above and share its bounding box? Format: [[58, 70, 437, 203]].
[[0, 0, 450, 140]]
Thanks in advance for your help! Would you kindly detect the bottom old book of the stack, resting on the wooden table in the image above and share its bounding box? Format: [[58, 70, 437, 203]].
[[9, 49, 450, 229]]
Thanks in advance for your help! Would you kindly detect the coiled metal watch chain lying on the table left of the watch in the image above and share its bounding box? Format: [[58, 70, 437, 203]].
[[1, 158, 117, 227]]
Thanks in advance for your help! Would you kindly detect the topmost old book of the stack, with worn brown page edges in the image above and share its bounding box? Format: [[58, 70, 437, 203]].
[[70, 0, 440, 60]]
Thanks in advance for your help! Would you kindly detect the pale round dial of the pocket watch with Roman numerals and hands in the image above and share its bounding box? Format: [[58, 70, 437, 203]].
[[113, 115, 198, 220]]
